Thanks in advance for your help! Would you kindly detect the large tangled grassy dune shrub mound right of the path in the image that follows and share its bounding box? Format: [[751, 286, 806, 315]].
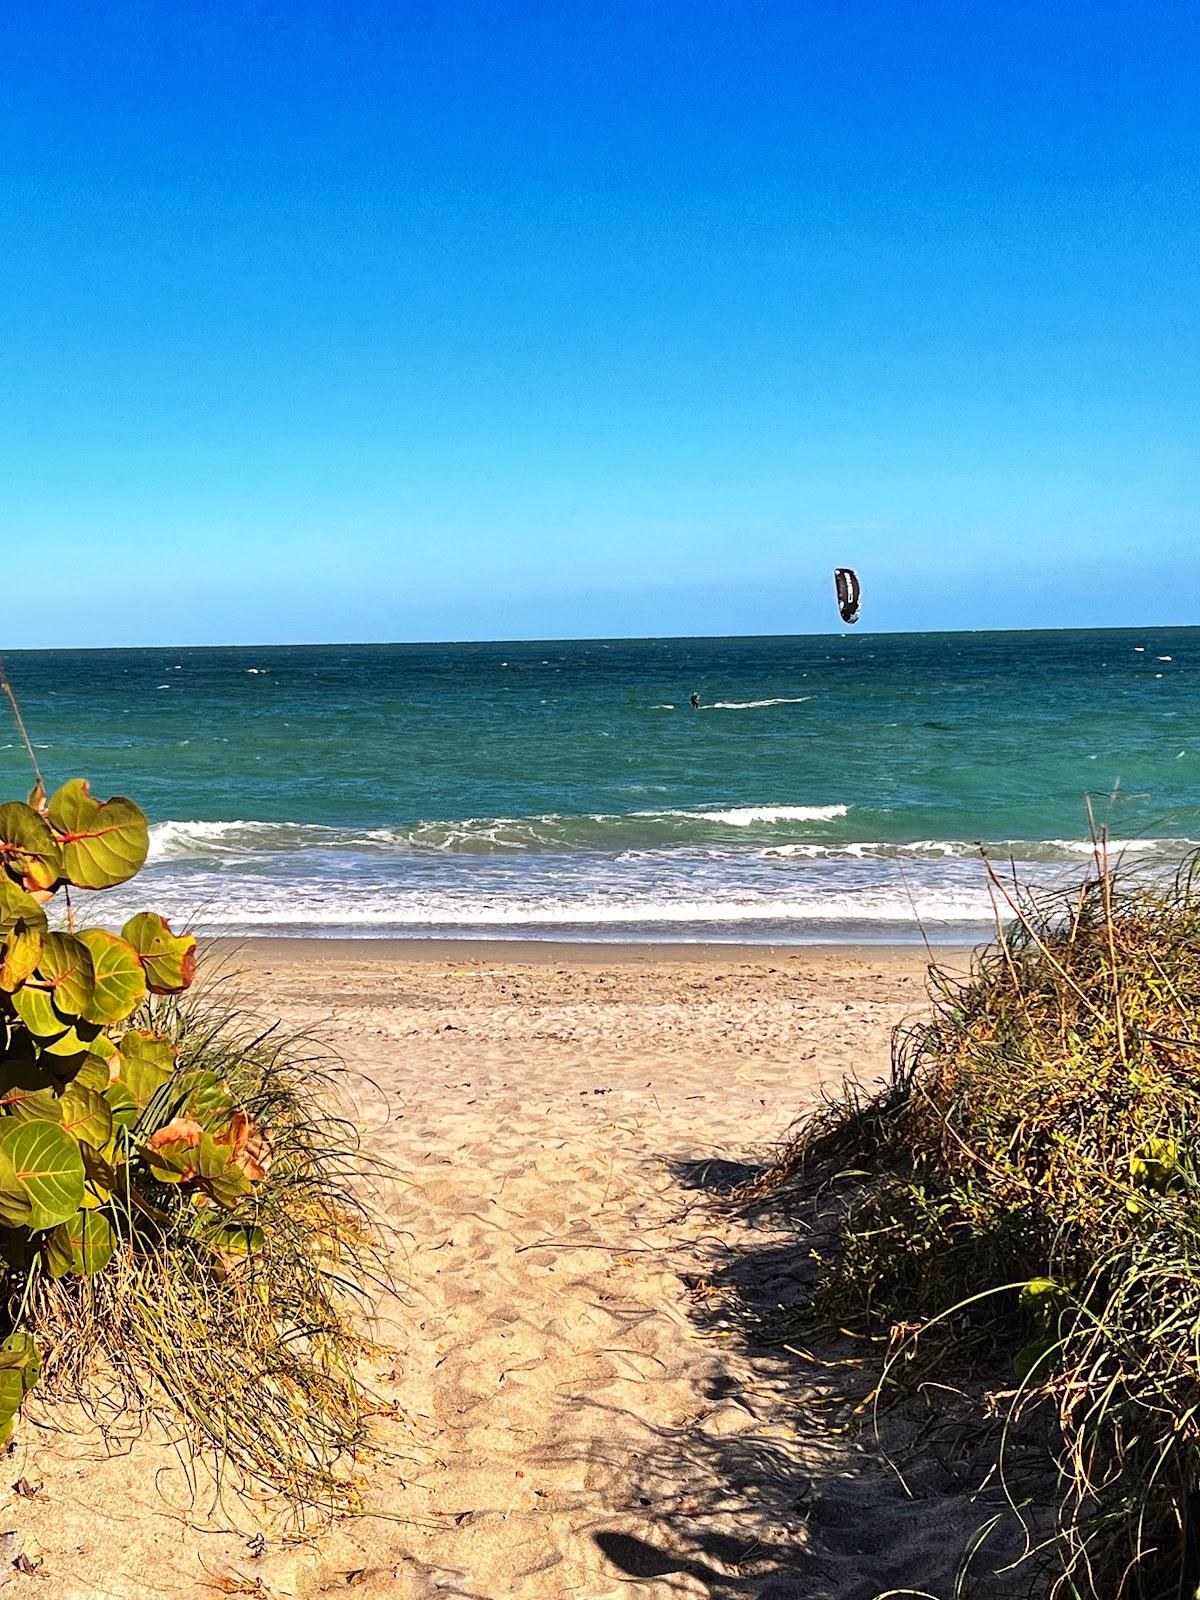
[[768, 851, 1200, 1600]]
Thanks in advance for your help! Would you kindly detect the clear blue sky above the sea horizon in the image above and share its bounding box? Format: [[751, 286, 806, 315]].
[[0, 0, 1200, 646]]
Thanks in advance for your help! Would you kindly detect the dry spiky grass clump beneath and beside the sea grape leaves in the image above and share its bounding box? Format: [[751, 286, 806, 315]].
[[29, 981, 395, 1525]]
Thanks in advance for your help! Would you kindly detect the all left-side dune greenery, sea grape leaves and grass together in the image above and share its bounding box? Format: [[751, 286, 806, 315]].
[[0, 779, 381, 1518]]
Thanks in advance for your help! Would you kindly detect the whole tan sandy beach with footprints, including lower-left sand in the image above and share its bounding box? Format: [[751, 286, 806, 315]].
[[3, 941, 1004, 1600]]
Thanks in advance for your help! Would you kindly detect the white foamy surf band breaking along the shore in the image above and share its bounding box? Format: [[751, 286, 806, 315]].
[[129, 805, 1194, 942]]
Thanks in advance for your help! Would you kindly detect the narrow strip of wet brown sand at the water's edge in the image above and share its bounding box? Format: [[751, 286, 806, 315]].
[[211, 934, 978, 966]]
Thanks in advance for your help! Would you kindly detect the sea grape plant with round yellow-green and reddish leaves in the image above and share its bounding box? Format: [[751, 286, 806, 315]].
[[0, 778, 270, 1442]]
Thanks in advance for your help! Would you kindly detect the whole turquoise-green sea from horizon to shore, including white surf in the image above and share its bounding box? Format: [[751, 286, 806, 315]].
[[0, 629, 1200, 939]]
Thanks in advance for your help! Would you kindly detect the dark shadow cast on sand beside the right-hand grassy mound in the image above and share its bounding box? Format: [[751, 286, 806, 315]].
[[592, 1160, 1049, 1600]]
